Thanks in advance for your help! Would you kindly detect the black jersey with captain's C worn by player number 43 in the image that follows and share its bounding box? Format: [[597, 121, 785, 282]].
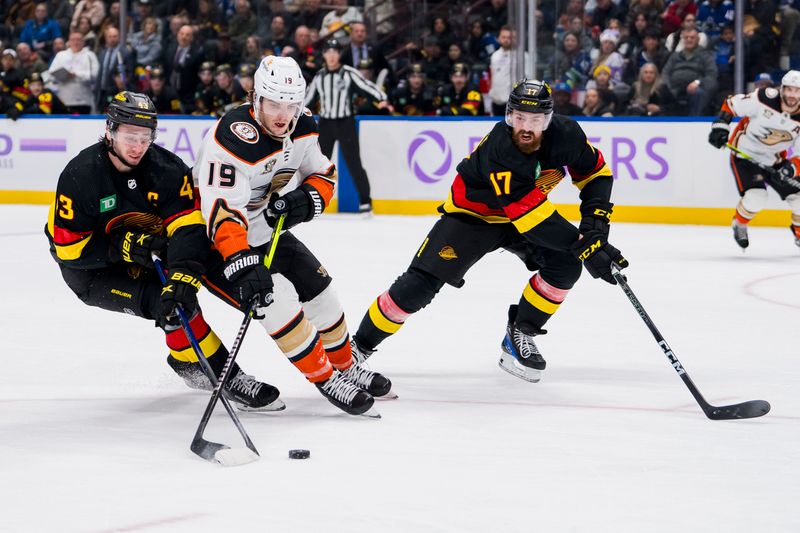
[[45, 142, 209, 268]]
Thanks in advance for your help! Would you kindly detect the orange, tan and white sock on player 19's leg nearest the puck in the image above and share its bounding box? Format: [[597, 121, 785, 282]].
[[270, 311, 334, 383]]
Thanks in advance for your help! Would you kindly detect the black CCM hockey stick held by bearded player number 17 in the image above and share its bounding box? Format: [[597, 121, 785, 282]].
[[611, 263, 770, 420]]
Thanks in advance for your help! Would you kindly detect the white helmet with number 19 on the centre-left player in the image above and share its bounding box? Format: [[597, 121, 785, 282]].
[[253, 56, 306, 135]]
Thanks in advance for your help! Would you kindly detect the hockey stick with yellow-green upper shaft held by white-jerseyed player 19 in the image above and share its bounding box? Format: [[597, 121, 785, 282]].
[[190, 215, 286, 466]]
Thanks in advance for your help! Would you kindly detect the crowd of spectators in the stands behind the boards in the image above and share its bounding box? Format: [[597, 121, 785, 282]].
[[0, 0, 800, 118]]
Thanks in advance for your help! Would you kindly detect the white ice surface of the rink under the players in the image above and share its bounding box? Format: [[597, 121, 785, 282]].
[[0, 206, 800, 533]]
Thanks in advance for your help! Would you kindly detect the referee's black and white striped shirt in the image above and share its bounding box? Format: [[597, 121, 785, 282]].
[[305, 65, 386, 119]]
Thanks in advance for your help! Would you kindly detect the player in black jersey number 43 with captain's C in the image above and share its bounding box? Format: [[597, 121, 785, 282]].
[[45, 91, 284, 410]]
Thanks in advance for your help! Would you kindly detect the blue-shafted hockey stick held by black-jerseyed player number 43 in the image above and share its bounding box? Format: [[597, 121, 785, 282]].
[[152, 252, 259, 466]]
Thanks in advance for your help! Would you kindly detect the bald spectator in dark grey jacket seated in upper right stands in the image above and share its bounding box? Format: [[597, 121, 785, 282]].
[[662, 28, 717, 116]]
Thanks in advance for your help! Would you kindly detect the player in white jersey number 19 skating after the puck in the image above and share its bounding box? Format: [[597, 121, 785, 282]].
[[193, 57, 391, 414]]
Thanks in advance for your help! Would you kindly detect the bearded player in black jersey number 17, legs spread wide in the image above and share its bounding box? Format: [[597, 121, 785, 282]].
[[354, 80, 627, 382]]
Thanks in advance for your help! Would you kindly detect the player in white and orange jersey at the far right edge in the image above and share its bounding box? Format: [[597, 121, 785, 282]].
[[708, 70, 800, 250]]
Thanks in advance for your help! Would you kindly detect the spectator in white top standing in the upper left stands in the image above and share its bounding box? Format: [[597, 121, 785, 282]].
[[46, 32, 100, 115]]
